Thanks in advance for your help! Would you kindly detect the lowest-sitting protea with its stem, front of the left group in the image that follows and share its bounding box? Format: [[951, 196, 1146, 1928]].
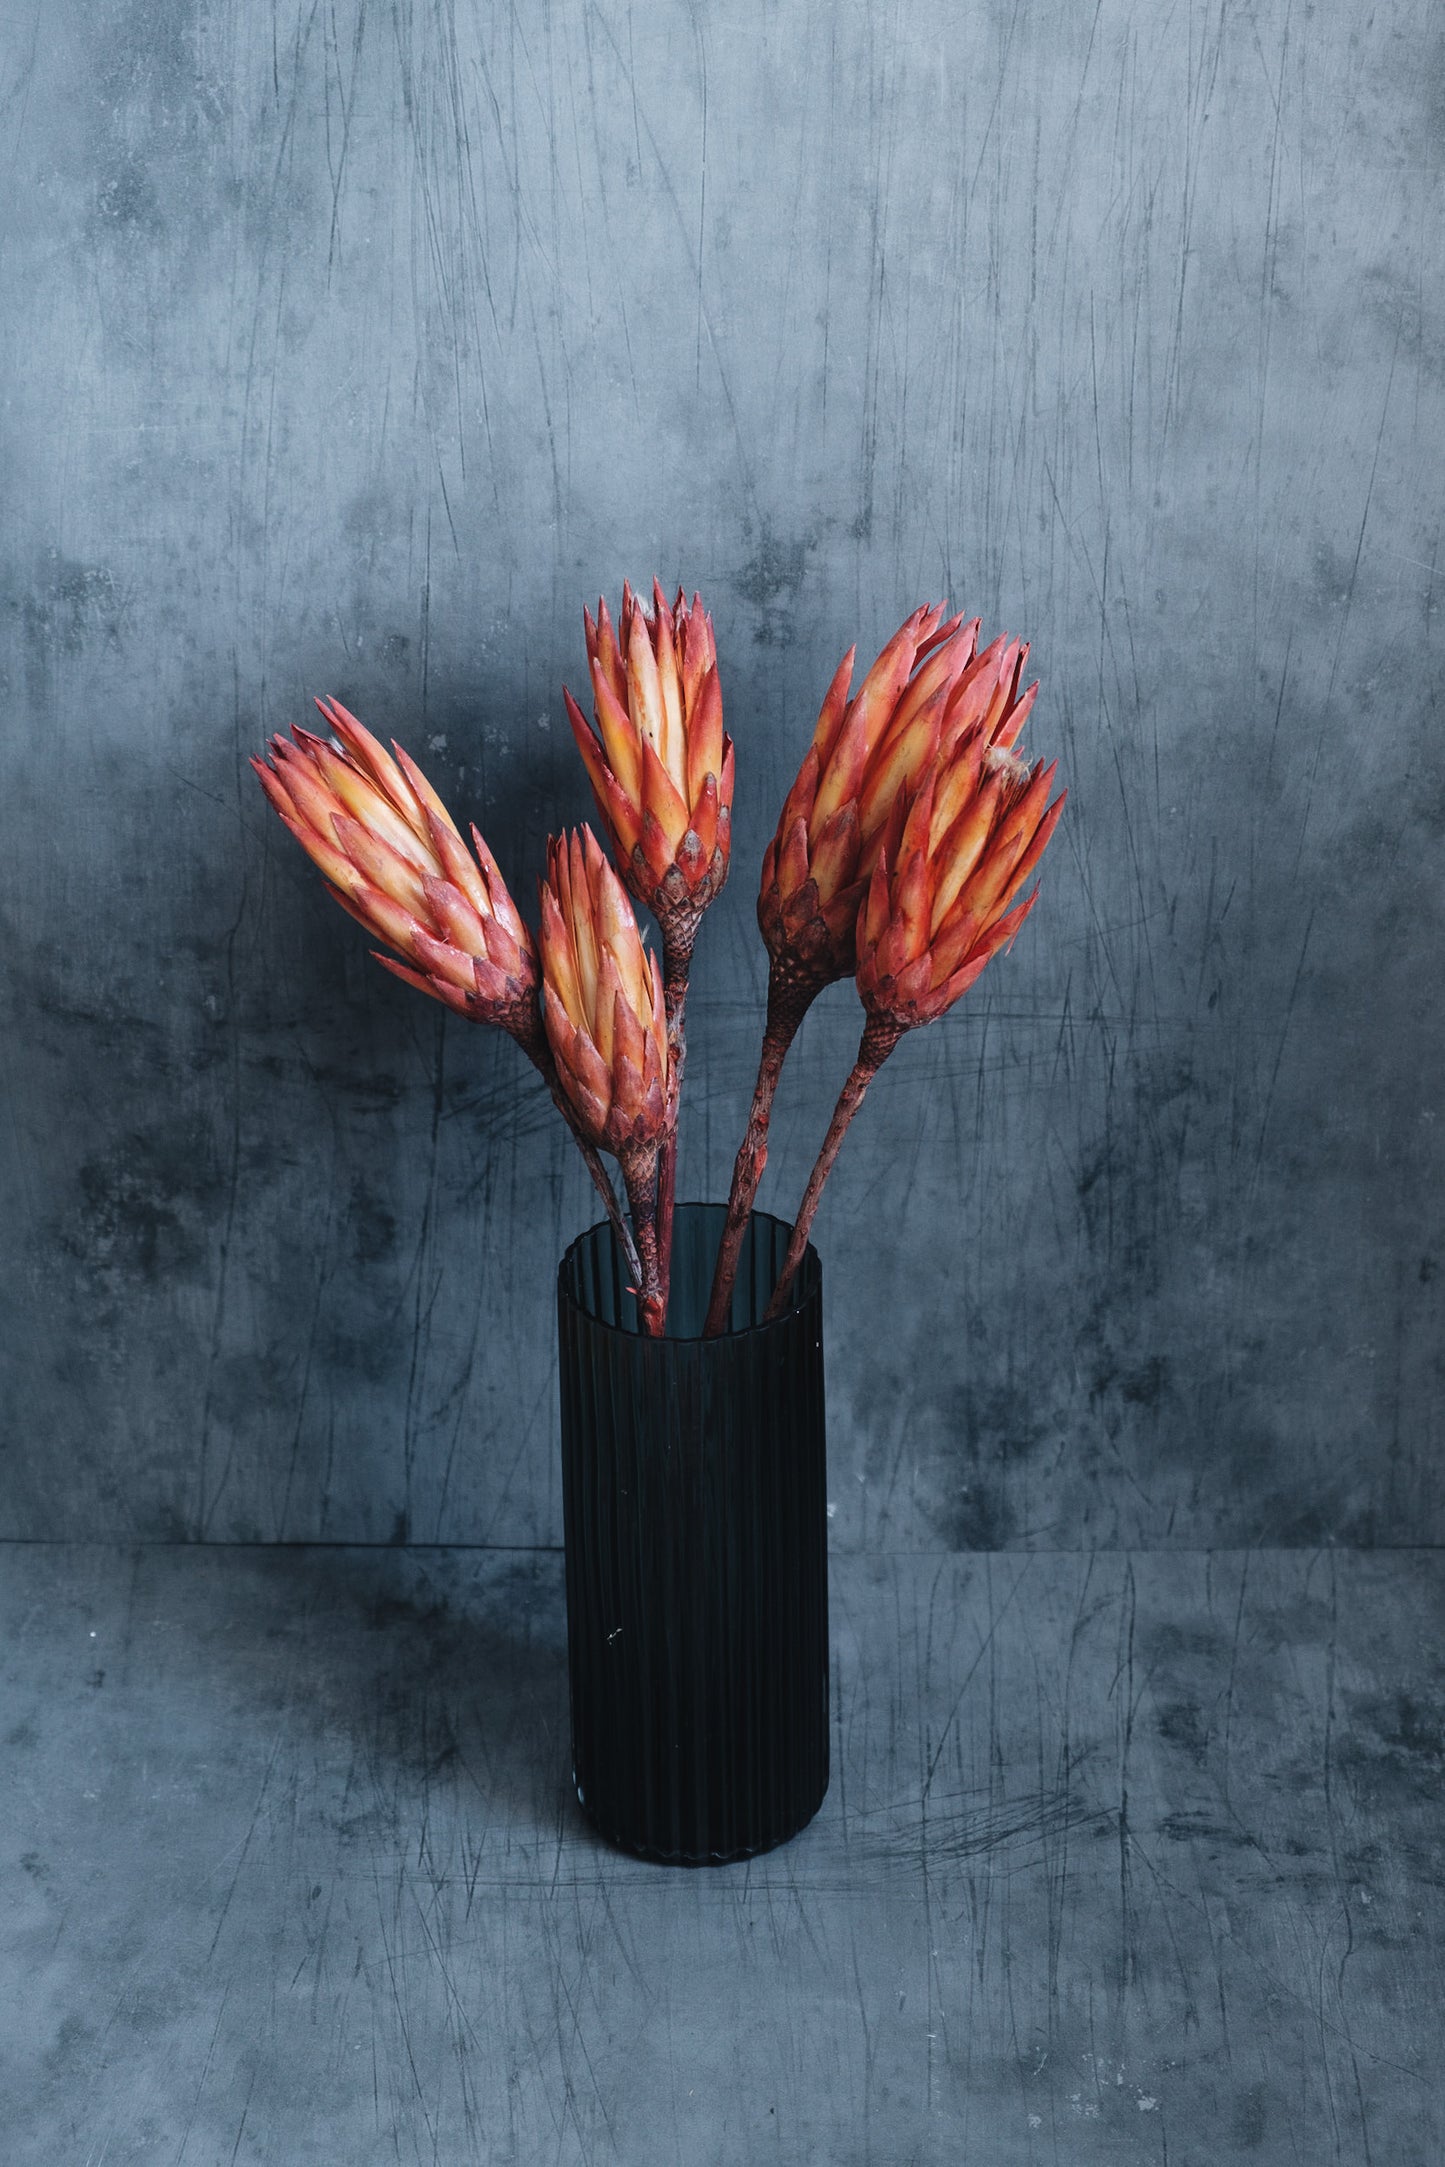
[[542, 828, 667, 1335]]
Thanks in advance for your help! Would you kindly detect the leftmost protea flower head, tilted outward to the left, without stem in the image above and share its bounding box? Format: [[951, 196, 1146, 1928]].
[[251, 700, 539, 1047]]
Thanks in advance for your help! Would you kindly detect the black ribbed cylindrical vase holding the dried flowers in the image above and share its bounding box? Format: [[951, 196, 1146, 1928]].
[[557, 1205, 828, 1866]]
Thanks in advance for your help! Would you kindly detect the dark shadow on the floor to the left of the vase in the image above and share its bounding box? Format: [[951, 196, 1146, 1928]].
[[149, 1547, 615, 1881]]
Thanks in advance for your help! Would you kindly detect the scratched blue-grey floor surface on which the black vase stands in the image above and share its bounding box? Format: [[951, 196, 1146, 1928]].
[[0, 1545, 1445, 2167]]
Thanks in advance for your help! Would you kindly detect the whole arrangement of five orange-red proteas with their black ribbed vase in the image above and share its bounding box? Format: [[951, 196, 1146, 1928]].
[[253, 581, 1064, 1864]]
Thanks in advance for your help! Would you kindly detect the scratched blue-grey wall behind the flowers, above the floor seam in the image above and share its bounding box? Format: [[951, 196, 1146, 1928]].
[[0, 0, 1445, 1547]]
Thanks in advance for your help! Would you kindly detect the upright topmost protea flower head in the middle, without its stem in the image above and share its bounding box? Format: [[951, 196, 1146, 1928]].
[[563, 581, 732, 927]]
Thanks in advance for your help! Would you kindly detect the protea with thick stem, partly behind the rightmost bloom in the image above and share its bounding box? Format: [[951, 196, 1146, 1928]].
[[706, 602, 1038, 1335]]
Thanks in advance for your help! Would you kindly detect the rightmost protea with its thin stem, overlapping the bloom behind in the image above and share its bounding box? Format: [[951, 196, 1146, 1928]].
[[765, 722, 1066, 1318]]
